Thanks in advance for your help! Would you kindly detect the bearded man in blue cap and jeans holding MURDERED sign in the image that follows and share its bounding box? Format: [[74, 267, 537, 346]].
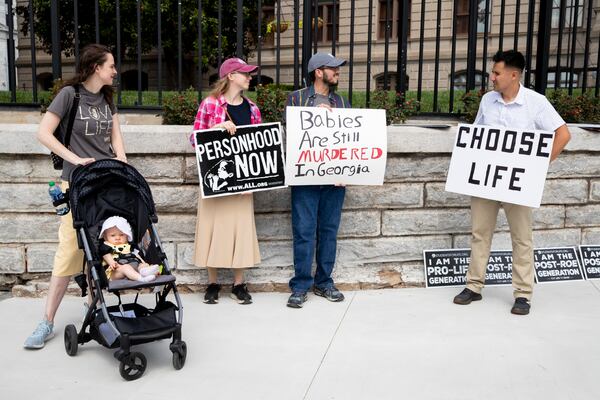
[[287, 53, 350, 308]]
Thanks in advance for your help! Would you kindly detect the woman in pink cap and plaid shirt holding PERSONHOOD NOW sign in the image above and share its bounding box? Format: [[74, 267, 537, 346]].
[[190, 58, 261, 304]]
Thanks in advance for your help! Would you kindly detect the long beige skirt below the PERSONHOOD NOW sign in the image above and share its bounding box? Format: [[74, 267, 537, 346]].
[[194, 194, 260, 268]]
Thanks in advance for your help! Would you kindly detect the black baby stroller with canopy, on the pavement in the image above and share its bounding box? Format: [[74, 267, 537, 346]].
[[64, 159, 187, 380]]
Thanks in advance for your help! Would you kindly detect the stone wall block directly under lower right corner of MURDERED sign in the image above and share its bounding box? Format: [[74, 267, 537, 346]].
[[344, 183, 423, 209]]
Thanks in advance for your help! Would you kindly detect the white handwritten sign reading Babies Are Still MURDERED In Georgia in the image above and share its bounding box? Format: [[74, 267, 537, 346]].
[[286, 107, 387, 185]]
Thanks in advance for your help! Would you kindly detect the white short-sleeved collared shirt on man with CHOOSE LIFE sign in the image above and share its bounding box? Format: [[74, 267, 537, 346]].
[[474, 84, 565, 132]]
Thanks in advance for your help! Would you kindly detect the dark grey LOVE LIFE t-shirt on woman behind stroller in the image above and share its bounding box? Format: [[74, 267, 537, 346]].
[[48, 85, 117, 180]]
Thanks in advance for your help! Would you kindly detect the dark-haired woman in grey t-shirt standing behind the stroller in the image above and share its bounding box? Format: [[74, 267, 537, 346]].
[[24, 44, 127, 349]]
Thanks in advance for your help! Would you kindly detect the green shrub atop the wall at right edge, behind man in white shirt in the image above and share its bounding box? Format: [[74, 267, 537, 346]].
[[548, 90, 600, 123]]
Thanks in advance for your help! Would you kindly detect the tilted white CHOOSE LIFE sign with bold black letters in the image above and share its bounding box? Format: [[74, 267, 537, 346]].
[[446, 124, 554, 208]]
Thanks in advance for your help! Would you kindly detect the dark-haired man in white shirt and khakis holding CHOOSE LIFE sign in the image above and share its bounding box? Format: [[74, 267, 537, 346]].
[[454, 50, 571, 315]]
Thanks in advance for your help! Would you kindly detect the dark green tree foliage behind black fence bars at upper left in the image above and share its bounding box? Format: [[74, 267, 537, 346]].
[[17, 0, 257, 76]]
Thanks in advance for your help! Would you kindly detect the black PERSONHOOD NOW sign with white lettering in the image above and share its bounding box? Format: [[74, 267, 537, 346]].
[[194, 122, 285, 198]]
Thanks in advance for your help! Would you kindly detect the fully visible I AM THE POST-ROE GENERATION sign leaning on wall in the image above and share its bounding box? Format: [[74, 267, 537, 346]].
[[533, 247, 584, 283]]
